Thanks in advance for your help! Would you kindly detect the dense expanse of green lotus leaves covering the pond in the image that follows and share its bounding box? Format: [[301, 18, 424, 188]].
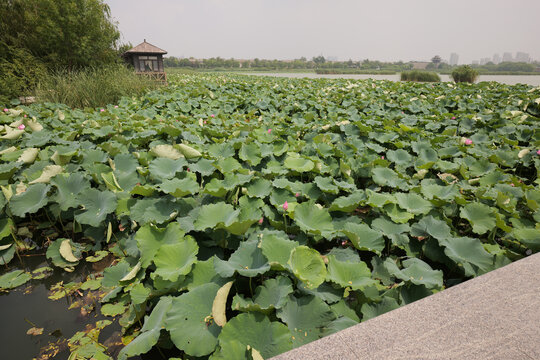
[[0, 74, 540, 359]]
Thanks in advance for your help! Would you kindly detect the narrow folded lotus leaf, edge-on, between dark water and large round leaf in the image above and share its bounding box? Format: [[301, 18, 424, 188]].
[[118, 296, 172, 360]]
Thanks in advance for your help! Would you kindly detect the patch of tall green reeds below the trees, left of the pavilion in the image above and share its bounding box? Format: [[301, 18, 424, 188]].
[[36, 65, 157, 108]]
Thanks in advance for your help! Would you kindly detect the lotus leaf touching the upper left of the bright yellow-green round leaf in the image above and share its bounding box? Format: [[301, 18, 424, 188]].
[[259, 232, 300, 270]]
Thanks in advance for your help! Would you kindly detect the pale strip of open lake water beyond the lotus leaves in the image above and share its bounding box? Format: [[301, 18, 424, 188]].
[[246, 72, 540, 86]]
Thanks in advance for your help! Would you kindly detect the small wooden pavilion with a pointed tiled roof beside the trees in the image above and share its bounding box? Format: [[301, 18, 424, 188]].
[[123, 39, 167, 83]]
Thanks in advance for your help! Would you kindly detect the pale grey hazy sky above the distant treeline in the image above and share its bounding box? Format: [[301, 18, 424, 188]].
[[105, 0, 540, 63]]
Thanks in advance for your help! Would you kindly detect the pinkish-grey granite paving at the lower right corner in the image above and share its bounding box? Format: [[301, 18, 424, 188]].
[[273, 254, 540, 360]]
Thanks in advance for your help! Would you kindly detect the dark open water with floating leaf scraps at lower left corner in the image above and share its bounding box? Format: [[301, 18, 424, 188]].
[[0, 256, 120, 360]]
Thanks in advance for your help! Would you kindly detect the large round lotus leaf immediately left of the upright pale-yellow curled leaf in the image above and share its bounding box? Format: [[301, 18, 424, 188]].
[[165, 283, 223, 356]]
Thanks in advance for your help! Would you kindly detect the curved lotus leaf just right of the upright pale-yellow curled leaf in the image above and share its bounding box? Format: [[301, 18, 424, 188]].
[[232, 276, 293, 313]]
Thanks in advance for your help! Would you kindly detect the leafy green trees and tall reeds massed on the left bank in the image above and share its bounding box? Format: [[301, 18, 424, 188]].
[[0, 0, 150, 107]]
